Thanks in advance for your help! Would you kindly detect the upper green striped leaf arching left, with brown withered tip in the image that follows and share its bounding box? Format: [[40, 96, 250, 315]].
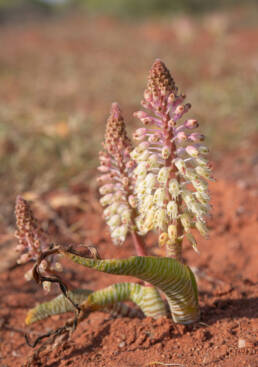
[[60, 250, 200, 324]]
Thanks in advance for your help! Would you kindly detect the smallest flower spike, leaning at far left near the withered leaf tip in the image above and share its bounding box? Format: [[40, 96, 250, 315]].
[[15, 196, 62, 291]]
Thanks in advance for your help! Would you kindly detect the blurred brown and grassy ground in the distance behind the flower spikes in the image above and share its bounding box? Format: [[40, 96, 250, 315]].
[[0, 0, 258, 230]]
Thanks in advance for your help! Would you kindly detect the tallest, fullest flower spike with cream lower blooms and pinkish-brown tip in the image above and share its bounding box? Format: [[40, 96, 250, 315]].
[[131, 60, 212, 259]]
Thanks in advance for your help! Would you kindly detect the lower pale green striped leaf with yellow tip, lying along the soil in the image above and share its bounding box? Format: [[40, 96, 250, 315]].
[[25, 283, 166, 325]]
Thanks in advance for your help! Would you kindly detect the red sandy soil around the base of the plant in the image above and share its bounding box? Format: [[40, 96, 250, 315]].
[[0, 139, 258, 367]]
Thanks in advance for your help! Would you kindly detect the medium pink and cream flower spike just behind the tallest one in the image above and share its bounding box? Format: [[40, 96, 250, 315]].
[[98, 103, 136, 245]]
